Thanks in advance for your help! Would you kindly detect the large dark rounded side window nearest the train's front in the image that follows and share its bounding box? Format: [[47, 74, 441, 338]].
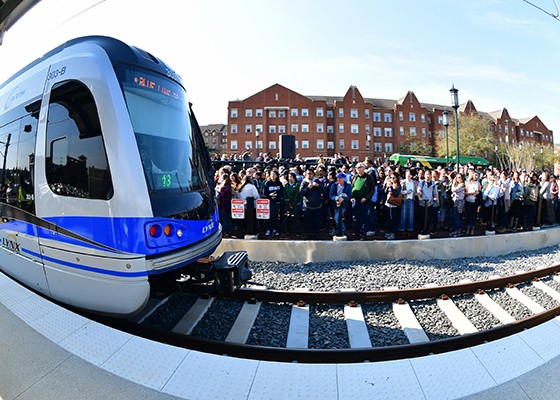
[[45, 81, 113, 200]]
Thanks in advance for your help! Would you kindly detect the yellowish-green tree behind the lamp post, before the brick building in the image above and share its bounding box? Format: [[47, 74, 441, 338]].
[[435, 115, 496, 158]]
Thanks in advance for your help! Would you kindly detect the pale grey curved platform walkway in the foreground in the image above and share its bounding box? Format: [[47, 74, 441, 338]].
[[0, 230, 560, 400]]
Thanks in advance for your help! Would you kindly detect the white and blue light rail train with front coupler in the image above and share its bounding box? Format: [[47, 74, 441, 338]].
[[0, 36, 250, 316]]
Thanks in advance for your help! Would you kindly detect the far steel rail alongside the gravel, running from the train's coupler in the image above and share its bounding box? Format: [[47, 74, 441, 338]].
[[223, 264, 560, 304]]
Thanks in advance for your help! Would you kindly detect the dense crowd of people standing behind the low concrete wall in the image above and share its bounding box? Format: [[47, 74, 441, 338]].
[[215, 157, 560, 240]]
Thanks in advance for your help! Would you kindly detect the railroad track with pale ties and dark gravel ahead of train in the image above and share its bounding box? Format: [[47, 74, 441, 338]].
[[98, 265, 560, 363]]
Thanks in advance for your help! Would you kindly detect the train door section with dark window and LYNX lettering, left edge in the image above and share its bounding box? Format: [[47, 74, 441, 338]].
[[0, 114, 49, 294]]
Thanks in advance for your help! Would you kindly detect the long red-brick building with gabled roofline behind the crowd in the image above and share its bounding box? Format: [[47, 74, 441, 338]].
[[227, 84, 553, 159]]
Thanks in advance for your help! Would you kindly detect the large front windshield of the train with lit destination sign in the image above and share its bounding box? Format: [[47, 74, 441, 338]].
[[117, 64, 214, 218]]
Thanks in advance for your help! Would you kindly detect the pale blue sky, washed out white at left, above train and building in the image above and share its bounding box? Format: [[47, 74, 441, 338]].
[[0, 0, 560, 140]]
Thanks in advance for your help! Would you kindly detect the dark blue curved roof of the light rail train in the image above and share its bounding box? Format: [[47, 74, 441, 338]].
[[0, 36, 183, 90]]
